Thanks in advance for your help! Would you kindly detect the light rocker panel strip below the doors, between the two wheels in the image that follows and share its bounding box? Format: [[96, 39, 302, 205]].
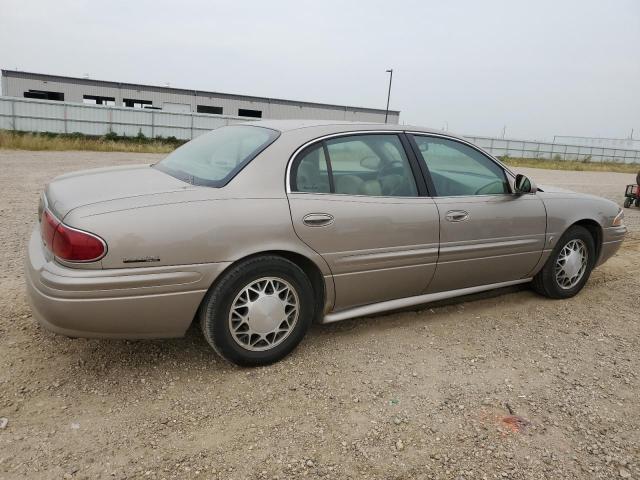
[[320, 278, 531, 323]]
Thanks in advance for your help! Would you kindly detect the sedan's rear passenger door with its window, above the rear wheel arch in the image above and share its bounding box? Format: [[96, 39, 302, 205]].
[[288, 132, 439, 311]]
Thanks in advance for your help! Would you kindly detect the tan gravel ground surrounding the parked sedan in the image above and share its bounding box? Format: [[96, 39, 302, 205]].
[[0, 151, 640, 479]]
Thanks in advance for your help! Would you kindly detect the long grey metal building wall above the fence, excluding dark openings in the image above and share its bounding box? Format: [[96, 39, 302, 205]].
[[2, 71, 400, 124]]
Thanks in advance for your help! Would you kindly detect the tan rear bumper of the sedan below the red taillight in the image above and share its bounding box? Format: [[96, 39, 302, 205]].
[[25, 227, 228, 339]]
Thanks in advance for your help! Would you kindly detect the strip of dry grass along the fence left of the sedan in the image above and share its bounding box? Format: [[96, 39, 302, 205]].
[[0, 130, 184, 153]]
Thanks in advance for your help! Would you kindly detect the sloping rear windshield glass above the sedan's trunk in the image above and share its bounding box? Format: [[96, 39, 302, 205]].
[[155, 125, 280, 187]]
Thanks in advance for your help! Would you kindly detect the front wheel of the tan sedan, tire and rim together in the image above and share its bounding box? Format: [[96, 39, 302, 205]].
[[532, 225, 596, 298]]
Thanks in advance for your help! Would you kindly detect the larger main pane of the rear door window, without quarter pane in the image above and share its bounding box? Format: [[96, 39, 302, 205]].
[[326, 134, 418, 197]]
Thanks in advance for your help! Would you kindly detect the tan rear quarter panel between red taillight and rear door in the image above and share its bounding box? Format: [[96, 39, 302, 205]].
[[65, 198, 329, 275]]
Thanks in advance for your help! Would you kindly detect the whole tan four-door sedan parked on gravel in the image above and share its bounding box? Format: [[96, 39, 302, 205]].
[[26, 121, 626, 365]]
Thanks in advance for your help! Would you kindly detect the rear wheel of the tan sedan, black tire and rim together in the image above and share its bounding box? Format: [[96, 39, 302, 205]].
[[198, 255, 315, 367]]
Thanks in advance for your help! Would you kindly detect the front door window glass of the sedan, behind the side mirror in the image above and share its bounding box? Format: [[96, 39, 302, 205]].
[[414, 136, 510, 197]]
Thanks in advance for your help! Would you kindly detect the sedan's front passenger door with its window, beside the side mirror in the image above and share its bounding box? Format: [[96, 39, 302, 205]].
[[410, 134, 546, 292]]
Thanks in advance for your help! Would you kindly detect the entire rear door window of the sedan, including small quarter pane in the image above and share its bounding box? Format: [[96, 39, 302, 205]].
[[291, 134, 418, 197]]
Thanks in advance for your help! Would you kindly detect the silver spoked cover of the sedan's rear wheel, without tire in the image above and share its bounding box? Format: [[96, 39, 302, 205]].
[[229, 277, 300, 352]]
